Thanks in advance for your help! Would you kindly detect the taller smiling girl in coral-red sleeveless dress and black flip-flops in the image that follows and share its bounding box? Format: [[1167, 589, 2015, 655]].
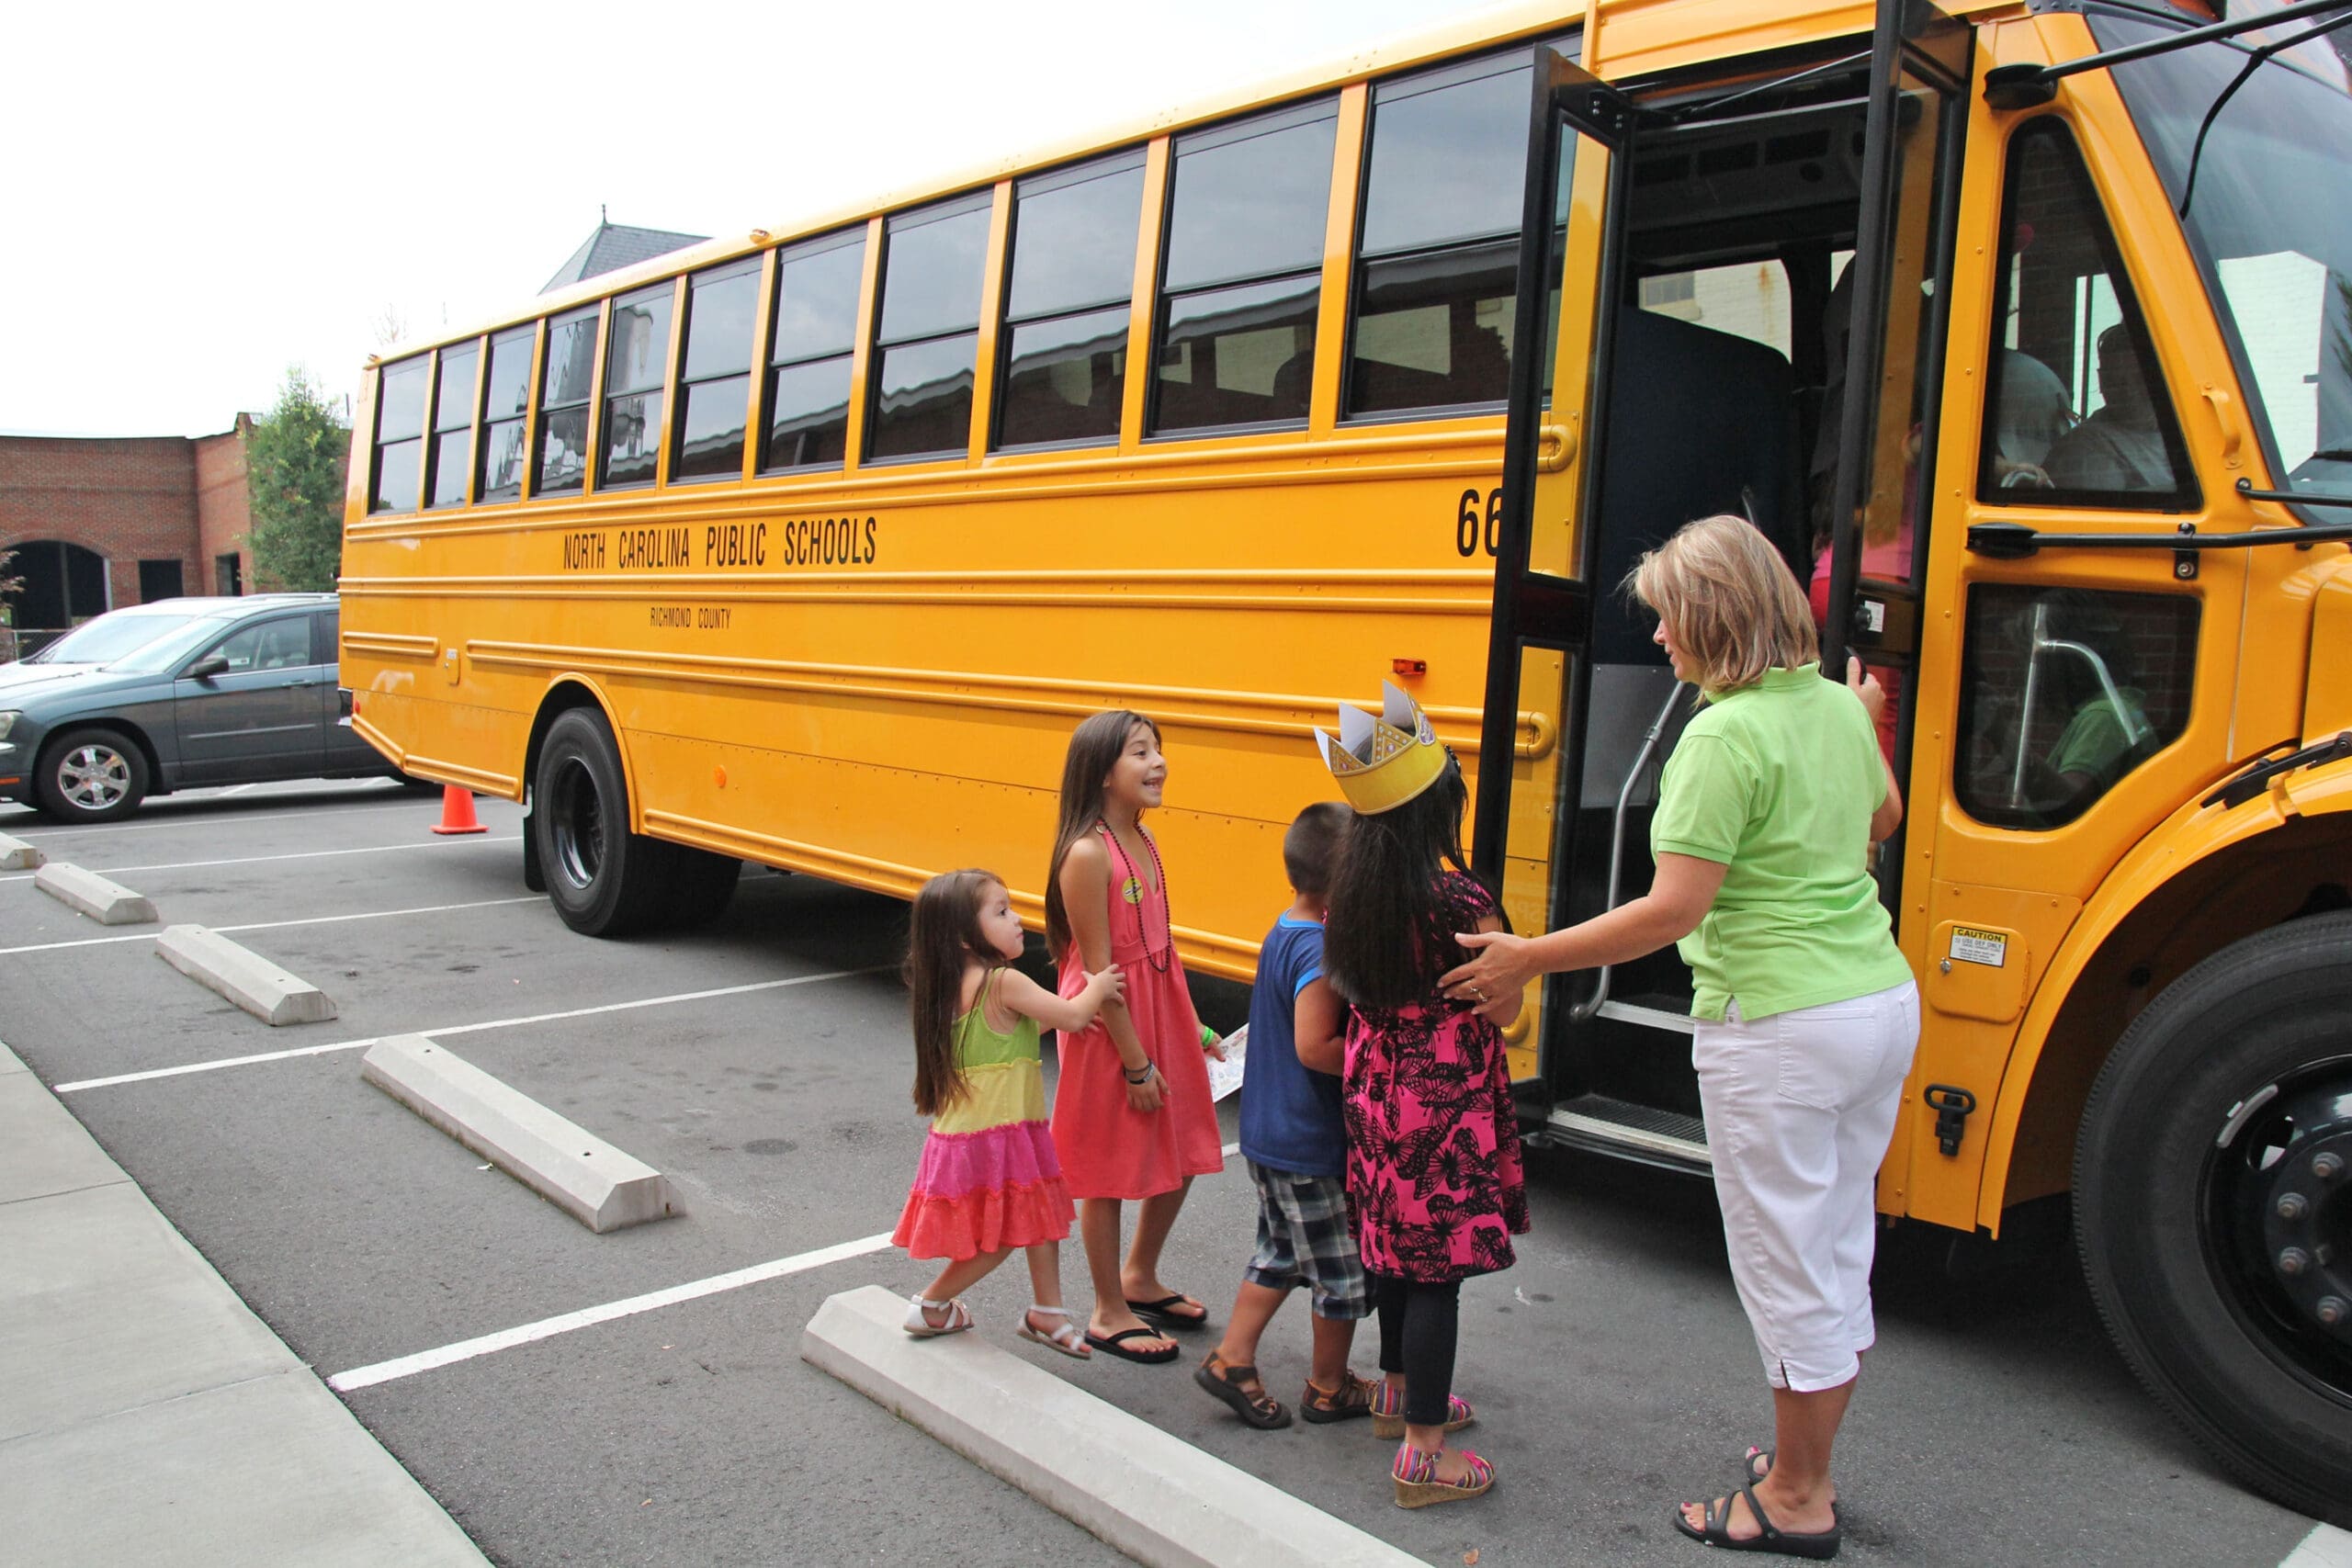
[[1045, 710, 1226, 1361]]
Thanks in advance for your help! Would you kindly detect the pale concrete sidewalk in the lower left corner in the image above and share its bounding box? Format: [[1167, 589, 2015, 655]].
[[0, 1046, 487, 1568]]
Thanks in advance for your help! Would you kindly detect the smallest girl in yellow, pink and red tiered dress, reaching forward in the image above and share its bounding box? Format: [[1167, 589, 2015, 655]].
[[891, 872, 1120, 1359]]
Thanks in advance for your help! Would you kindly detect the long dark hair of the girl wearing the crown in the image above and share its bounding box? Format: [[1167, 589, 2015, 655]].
[[1324, 757, 1470, 1006]]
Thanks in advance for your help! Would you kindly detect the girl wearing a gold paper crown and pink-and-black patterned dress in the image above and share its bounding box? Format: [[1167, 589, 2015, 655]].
[[1317, 686, 1526, 1506]]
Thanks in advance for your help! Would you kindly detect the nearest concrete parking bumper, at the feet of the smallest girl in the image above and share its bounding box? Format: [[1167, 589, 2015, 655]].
[[799, 1286, 1420, 1568]]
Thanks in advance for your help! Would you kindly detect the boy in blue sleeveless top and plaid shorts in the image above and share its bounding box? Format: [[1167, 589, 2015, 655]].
[[1193, 802, 1371, 1427]]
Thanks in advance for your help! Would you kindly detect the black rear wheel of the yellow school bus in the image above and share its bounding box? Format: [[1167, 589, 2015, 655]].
[[532, 707, 671, 936]]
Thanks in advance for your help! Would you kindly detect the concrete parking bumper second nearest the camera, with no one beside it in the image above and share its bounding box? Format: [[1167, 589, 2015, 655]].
[[360, 1034, 673, 1235]]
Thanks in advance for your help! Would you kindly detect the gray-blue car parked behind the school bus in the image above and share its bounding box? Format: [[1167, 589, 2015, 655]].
[[0, 592, 395, 823]]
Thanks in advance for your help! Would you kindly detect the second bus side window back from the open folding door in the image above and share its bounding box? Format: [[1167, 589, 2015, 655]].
[[1150, 98, 1345, 433]]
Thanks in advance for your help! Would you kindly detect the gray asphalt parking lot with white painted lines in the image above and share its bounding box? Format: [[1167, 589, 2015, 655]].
[[0, 783, 2312, 1568]]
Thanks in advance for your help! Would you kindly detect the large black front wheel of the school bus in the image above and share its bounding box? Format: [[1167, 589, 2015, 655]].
[[2075, 915, 2352, 1523]]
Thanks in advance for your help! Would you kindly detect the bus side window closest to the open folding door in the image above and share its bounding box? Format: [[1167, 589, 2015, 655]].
[[1348, 56, 1529, 416]]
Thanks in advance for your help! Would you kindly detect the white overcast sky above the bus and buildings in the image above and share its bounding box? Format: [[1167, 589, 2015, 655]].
[[0, 0, 1496, 434]]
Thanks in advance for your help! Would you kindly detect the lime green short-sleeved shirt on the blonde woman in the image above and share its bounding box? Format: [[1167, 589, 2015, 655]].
[[1649, 665, 1912, 1021]]
